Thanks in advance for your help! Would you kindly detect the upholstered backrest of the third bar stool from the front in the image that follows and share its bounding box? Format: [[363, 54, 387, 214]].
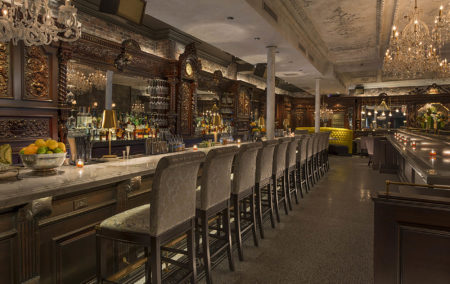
[[232, 142, 262, 194]]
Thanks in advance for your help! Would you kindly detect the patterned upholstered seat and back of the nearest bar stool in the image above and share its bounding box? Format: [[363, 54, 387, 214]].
[[100, 152, 205, 236]]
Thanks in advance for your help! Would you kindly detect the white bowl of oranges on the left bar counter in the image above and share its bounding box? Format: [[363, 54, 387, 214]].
[[19, 139, 66, 172]]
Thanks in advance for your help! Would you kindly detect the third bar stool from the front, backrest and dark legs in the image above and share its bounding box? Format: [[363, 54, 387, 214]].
[[231, 142, 262, 261]]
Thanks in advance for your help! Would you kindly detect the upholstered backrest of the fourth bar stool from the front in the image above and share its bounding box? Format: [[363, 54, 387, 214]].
[[255, 140, 278, 183]]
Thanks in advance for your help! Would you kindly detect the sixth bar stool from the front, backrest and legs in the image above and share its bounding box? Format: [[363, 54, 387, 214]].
[[284, 137, 299, 211]]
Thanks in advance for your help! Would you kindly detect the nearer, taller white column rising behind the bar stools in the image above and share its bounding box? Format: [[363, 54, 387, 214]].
[[266, 46, 277, 139]]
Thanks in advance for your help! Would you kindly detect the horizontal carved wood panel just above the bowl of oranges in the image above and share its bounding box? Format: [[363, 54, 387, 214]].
[[0, 117, 52, 141]]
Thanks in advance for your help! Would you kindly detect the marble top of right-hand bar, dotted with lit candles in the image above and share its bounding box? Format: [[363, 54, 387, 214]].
[[387, 130, 450, 185]]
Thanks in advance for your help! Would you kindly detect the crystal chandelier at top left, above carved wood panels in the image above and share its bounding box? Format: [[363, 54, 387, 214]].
[[0, 0, 81, 46]]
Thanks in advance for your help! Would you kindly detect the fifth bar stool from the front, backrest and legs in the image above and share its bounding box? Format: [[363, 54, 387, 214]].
[[272, 138, 291, 223]]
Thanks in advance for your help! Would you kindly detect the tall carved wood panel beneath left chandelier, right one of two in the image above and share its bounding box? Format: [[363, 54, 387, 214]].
[[23, 46, 51, 101]]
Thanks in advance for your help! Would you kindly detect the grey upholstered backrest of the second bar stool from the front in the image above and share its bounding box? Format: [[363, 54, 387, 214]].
[[200, 146, 239, 210]]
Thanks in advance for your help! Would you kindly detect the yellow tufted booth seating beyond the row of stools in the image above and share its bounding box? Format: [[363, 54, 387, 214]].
[[295, 127, 353, 155]]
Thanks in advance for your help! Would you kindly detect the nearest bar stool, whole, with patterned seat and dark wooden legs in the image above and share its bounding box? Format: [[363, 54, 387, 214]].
[[96, 152, 205, 283]]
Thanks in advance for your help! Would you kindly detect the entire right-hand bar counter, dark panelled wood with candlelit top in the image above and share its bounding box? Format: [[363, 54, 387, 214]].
[[373, 130, 450, 284]]
